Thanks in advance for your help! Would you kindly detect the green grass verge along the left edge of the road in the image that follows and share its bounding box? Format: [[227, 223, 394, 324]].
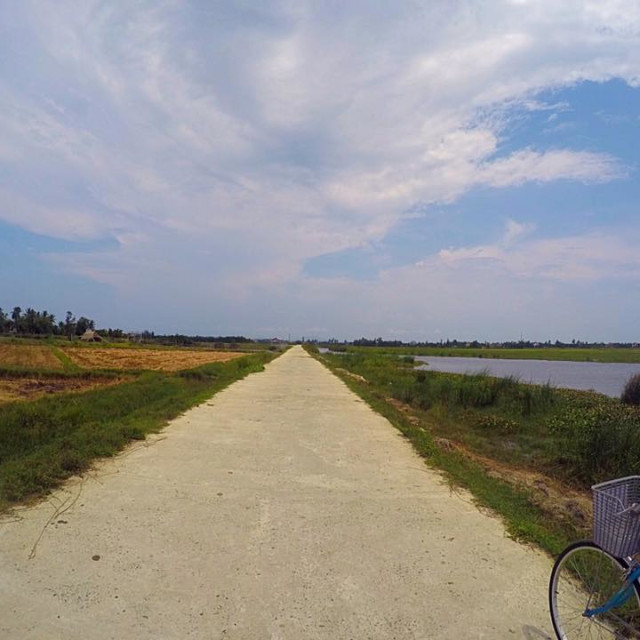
[[0, 353, 274, 510]]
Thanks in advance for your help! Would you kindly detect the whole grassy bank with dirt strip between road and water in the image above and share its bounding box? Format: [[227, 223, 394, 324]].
[[312, 344, 640, 554]]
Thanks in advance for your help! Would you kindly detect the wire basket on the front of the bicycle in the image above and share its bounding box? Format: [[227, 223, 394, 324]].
[[591, 476, 640, 558]]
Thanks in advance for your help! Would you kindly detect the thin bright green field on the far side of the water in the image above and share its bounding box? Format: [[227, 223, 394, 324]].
[[340, 346, 640, 363]]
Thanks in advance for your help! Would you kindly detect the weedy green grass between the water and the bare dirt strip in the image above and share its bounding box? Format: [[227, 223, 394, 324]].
[[328, 353, 640, 489]]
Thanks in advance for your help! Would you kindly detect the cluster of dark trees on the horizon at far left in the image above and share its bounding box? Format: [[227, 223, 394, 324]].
[[0, 307, 95, 340]]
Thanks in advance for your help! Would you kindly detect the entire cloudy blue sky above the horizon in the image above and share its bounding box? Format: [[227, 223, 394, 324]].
[[0, 0, 640, 341]]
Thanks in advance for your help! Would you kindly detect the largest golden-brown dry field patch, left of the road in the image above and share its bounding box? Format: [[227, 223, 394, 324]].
[[63, 347, 246, 371]]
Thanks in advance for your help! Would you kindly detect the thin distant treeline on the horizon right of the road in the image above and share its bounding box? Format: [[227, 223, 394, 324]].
[[326, 338, 640, 349]]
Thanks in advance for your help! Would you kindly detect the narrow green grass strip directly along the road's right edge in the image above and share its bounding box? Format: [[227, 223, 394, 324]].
[[309, 349, 584, 554]]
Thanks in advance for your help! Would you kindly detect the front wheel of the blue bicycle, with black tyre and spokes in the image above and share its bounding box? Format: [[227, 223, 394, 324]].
[[549, 541, 640, 640]]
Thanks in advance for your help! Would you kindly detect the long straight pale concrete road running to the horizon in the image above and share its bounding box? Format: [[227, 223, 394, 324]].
[[0, 348, 550, 640]]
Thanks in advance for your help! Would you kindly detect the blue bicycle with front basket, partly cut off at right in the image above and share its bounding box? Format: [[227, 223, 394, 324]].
[[549, 476, 640, 640]]
